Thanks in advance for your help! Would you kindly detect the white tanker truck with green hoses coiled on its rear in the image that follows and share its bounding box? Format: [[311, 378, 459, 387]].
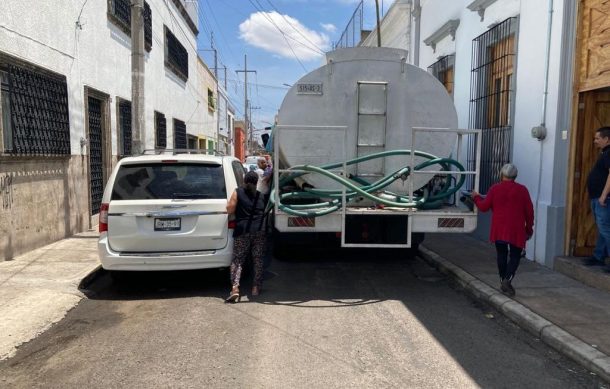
[[270, 47, 480, 252]]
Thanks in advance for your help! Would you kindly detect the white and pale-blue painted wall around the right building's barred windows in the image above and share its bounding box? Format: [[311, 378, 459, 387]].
[[367, 0, 576, 266]]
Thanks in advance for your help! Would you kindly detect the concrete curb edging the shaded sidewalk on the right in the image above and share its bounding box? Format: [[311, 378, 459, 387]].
[[419, 245, 610, 382]]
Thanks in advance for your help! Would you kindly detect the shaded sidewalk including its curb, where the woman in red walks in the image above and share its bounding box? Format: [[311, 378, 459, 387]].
[[420, 234, 610, 382]]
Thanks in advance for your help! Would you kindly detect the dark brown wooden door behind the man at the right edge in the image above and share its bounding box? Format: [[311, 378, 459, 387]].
[[570, 91, 610, 256]]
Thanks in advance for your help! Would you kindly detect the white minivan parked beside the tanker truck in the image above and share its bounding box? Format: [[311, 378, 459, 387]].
[[98, 151, 244, 271]]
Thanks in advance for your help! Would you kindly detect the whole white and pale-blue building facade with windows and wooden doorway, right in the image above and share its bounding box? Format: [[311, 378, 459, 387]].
[[356, 0, 610, 267]]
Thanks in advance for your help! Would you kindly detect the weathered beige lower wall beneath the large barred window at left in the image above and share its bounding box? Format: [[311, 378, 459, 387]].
[[0, 155, 92, 260]]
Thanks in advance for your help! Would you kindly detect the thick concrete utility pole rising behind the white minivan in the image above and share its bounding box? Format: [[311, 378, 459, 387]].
[[131, 0, 146, 155]]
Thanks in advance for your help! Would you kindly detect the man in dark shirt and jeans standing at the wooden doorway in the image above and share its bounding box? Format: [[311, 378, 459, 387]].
[[583, 127, 610, 271]]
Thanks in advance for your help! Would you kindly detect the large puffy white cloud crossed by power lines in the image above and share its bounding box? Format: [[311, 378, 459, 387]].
[[239, 11, 330, 61]]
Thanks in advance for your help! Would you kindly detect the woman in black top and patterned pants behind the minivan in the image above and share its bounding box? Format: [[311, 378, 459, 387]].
[[226, 172, 265, 303]]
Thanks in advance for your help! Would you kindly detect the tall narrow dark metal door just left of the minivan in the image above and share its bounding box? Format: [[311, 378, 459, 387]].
[[88, 96, 104, 215]]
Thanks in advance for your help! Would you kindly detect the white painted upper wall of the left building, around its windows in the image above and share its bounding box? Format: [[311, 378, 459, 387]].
[[0, 0, 207, 155]]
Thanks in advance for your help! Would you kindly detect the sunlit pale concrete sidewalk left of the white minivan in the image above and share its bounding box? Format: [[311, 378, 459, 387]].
[[0, 232, 99, 360]]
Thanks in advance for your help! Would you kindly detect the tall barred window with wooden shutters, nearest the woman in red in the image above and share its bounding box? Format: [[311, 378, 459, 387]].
[[468, 17, 518, 193]]
